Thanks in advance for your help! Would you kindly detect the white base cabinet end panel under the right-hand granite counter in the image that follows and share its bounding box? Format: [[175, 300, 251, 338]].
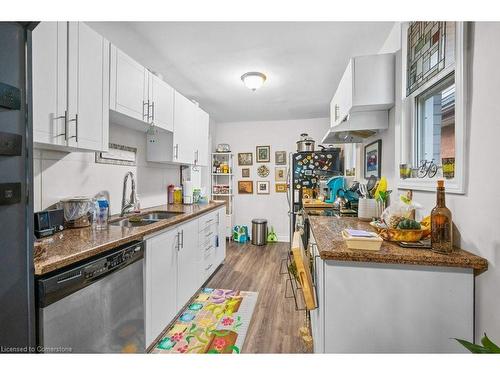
[[310, 226, 474, 353]]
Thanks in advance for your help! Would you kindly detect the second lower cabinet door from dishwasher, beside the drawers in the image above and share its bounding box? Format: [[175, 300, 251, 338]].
[[177, 220, 202, 310]]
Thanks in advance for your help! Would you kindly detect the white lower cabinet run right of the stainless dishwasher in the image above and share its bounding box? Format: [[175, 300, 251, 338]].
[[144, 209, 226, 347]]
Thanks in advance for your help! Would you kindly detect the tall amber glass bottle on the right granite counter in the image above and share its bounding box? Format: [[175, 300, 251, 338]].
[[431, 180, 453, 254]]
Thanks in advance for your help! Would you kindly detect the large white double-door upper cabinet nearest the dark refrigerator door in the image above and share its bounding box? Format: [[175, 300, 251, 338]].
[[33, 22, 109, 151]]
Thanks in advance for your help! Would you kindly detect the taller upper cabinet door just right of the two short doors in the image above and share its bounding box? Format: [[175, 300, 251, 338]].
[[173, 91, 196, 164]]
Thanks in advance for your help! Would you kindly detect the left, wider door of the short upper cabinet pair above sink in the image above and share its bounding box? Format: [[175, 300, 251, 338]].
[[110, 46, 148, 122]]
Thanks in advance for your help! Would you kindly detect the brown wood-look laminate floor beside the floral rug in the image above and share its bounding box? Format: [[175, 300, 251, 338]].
[[206, 242, 307, 353]]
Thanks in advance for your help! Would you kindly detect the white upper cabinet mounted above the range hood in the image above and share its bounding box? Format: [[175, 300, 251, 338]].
[[330, 53, 395, 126]]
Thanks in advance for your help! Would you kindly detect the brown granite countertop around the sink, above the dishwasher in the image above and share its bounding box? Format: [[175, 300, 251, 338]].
[[33, 202, 225, 276]]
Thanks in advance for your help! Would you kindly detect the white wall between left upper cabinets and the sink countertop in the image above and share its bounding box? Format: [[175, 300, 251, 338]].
[[34, 124, 179, 214]]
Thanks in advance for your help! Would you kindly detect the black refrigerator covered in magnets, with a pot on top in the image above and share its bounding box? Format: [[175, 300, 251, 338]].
[[288, 148, 342, 246]]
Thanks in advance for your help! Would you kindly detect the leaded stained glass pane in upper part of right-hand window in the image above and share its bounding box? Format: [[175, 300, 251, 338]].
[[406, 21, 455, 95]]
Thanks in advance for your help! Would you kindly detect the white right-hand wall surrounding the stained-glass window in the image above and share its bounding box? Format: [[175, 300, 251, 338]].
[[368, 22, 500, 342]]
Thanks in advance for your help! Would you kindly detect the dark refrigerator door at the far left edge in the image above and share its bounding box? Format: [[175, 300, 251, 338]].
[[0, 22, 35, 352]]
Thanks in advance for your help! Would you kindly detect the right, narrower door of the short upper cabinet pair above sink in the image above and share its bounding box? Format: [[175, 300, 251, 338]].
[[149, 73, 174, 131]]
